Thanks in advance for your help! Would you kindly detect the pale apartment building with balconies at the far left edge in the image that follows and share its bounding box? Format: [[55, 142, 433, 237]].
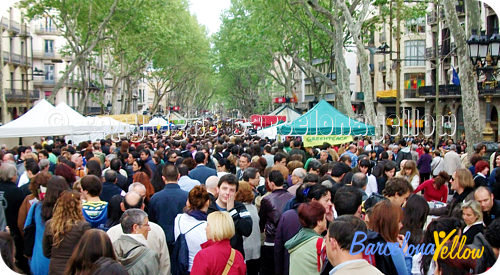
[[0, 7, 40, 122]]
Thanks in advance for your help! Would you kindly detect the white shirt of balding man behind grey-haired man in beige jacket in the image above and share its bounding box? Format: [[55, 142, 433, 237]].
[[106, 221, 170, 275]]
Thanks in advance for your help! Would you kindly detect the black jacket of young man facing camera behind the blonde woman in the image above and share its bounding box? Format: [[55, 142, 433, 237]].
[[207, 201, 253, 257]]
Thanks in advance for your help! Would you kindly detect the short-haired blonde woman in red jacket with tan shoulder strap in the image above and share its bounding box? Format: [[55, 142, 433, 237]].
[[191, 211, 246, 275]]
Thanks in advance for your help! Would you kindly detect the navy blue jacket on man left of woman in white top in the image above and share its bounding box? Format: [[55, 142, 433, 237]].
[[149, 183, 188, 245]]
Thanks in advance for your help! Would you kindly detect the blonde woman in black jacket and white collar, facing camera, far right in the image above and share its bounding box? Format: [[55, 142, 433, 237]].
[[462, 200, 485, 244]]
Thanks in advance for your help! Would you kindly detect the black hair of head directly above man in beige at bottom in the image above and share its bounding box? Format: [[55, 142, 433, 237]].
[[333, 185, 363, 216]]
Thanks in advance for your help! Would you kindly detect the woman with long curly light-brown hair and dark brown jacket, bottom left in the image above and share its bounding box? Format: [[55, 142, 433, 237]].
[[42, 191, 90, 275]]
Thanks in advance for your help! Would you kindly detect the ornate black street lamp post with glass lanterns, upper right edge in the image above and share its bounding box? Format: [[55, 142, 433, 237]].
[[467, 29, 500, 141]]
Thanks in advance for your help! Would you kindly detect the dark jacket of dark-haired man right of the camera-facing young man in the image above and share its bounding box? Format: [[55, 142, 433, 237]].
[[259, 189, 293, 243]]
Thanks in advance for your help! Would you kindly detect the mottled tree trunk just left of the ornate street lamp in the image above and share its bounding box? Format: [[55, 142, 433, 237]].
[[443, 0, 482, 155]]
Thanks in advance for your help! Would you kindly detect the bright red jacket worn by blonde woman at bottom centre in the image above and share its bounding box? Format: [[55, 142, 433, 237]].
[[191, 240, 247, 275]]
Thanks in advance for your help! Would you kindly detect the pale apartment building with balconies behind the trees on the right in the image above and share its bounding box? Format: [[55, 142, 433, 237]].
[[360, 0, 500, 141]]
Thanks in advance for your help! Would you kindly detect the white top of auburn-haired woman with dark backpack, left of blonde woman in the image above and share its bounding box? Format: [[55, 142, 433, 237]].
[[174, 213, 207, 271]]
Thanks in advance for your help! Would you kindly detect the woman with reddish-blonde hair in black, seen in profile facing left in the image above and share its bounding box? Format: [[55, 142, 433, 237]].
[[429, 168, 474, 218]]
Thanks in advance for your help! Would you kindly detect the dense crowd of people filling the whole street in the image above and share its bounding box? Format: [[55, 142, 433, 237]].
[[0, 134, 500, 275]]
